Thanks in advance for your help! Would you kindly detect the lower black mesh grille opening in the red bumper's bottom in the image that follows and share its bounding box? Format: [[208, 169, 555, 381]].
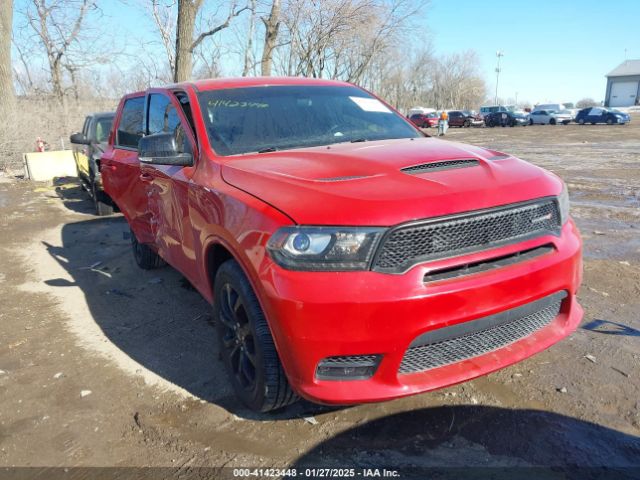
[[399, 291, 567, 374]]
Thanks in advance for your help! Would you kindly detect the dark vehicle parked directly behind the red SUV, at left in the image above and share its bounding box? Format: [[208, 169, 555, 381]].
[[69, 112, 115, 215]]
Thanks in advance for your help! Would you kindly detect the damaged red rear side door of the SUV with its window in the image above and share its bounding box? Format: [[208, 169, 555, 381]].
[[100, 94, 153, 243]]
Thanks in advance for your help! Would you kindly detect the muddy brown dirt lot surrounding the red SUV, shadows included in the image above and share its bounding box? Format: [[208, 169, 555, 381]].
[[0, 116, 640, 478]]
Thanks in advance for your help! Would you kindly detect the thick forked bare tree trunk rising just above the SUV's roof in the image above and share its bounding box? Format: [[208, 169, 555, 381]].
[[173, 0, 249, 82]]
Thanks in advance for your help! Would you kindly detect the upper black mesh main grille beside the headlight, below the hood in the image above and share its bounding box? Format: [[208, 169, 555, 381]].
[[373, 198, 560, 273]]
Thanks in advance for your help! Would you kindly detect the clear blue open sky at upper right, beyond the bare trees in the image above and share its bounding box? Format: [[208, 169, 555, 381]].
[[418, 0, 640, 103]]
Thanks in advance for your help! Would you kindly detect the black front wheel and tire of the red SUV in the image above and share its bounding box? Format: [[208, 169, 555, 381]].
[[213, 260, 298, 412]]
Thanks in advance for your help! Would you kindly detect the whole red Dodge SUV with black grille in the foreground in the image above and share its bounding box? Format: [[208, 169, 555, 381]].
[[101, 78, 582, 411]]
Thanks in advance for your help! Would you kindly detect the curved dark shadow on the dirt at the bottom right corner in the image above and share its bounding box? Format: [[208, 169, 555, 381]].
[[292, 406, 640, 480]]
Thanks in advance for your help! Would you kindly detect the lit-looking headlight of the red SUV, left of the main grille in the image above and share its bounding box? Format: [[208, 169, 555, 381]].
[[267, 227, 385, 272]]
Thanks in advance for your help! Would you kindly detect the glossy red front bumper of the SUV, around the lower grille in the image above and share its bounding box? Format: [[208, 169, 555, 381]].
[[261, 220, 582, 404]]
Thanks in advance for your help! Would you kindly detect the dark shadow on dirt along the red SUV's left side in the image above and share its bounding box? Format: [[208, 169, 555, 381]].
[[43, 214, 338, 421]]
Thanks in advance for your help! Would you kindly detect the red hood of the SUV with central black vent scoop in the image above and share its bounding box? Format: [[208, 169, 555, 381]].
[[222, 138, 562, 226]]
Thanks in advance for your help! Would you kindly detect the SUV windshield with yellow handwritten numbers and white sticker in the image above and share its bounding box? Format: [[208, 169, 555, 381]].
[[198, 85, 421, 155]]
